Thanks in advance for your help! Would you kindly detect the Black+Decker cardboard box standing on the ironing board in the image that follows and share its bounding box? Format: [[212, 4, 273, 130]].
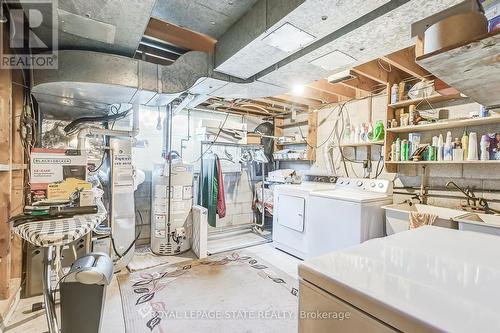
[[30, 148, 92, 201]]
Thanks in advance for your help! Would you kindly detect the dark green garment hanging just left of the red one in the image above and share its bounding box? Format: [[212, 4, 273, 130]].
[[199, 154, 219, 227]]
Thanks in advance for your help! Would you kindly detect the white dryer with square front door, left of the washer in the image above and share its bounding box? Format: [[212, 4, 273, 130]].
[[273, 176, 337, 259]]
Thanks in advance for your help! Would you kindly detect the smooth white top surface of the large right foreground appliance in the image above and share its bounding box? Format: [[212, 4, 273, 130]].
[[300, 227, 500, 333]]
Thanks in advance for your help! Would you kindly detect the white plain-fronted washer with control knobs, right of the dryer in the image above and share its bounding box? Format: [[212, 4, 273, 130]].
[[307, 178, 392, 258]]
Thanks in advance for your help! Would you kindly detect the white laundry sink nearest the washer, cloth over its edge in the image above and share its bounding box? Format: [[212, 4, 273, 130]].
[[382, 203, 464, 235]]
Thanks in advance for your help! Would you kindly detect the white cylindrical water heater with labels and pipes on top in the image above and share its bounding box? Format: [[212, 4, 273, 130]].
[[151, 160, 193, 255]]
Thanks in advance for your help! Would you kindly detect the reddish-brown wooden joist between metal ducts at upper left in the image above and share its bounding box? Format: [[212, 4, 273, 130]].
[[144, 18, 217, 53]]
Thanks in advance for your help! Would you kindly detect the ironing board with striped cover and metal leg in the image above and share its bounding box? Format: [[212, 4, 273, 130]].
[[12, 213, 106, 333]]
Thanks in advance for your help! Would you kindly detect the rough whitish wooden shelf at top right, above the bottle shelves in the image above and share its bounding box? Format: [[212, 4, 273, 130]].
[[416, 30, 500, 107]]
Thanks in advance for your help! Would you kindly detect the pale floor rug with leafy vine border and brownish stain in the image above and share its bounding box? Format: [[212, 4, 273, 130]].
[[118, 251, 298, 333]]
